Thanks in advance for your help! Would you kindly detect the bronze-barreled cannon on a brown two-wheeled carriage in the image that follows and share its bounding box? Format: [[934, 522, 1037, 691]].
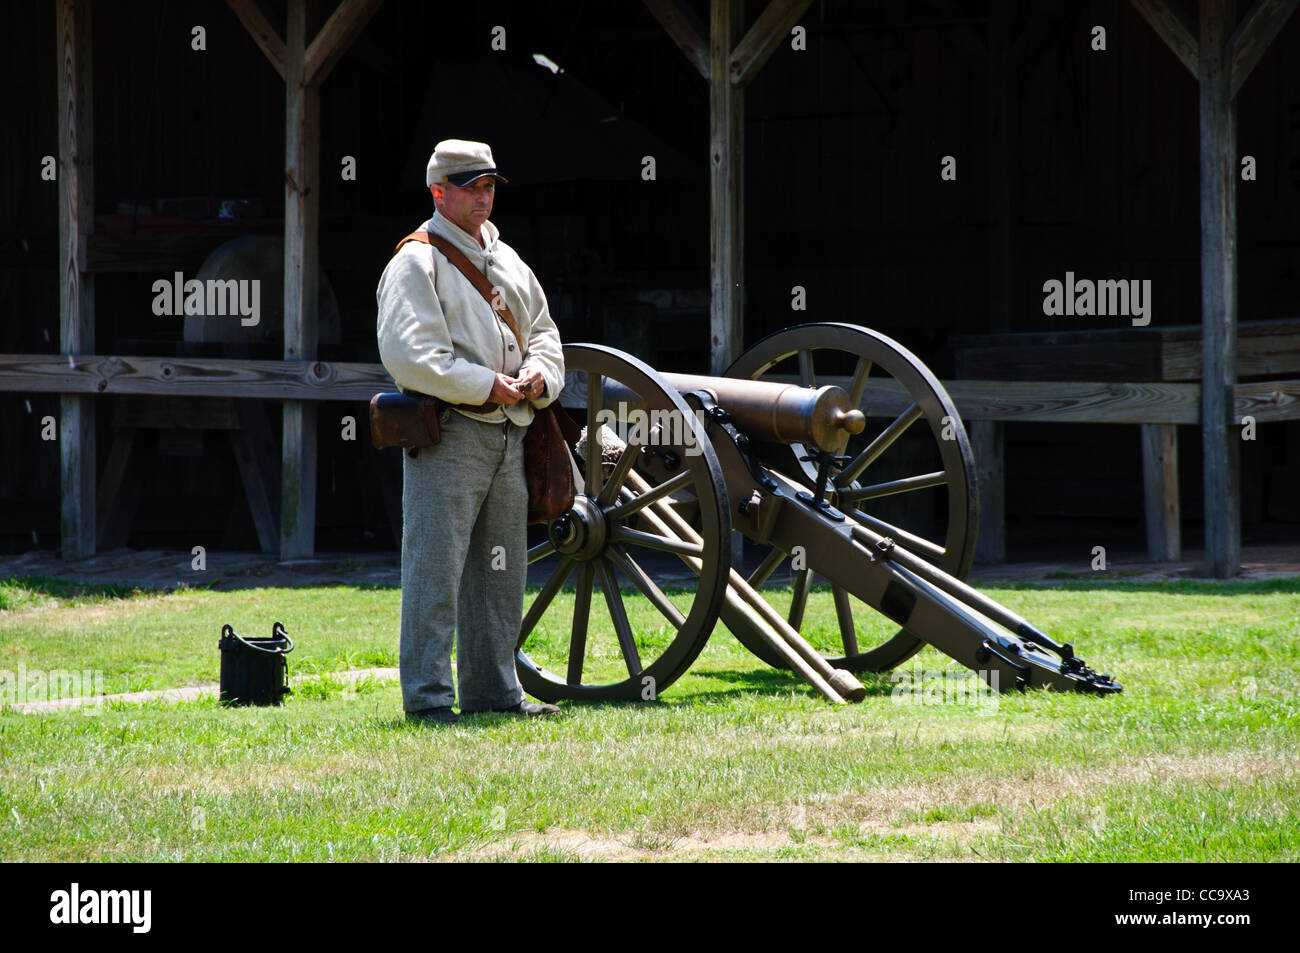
[[516, 322, 1121, 703]]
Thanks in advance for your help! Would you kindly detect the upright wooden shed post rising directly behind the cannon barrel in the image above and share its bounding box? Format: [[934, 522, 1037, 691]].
[[709, 0, 745, 374]]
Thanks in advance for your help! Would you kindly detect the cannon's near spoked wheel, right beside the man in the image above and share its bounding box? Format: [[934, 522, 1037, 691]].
[[517, 345, 731, 702]]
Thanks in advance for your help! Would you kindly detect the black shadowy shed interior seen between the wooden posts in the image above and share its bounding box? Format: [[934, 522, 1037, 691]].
[[0, 0, 1300, 559]]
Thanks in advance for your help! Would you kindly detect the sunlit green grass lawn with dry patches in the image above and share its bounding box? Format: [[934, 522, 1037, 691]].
[[0, 580, 1300, 862]]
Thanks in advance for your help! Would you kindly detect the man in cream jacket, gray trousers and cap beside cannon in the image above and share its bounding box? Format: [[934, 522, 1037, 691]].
[[376, 139, 564, 724]]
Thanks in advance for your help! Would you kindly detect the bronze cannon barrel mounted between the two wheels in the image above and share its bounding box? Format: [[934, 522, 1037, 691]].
[[603, 374, 867, 450]]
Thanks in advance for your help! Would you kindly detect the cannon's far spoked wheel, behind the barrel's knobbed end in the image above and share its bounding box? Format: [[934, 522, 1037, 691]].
[[727, 322, 979, 672]]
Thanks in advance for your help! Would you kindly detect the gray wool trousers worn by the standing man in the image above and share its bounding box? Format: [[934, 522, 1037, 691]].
[[399, 410, 528, 711]]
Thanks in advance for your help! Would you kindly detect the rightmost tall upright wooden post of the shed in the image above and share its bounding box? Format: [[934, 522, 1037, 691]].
[[1200, 0, 1242, 579]]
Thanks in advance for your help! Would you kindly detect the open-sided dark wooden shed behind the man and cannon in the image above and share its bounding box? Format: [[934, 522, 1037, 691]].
[[0, 0, 1300, 576]]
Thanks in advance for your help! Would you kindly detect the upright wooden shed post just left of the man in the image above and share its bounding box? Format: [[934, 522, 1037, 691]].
[[280, 0, 320, 559]]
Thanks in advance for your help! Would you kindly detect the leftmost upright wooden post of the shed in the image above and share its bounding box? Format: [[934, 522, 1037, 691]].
[[55, 0, 95, 559]]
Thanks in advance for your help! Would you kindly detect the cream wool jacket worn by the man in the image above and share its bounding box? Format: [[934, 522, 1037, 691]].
[[374, 212, 564, 426]]
